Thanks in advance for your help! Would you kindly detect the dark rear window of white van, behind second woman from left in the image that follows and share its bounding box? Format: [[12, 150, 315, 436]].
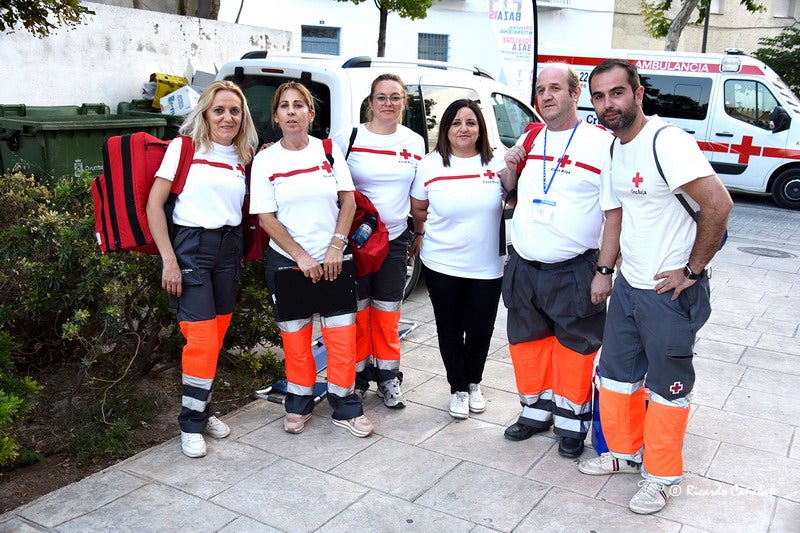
[[227, 76, 331, 145]]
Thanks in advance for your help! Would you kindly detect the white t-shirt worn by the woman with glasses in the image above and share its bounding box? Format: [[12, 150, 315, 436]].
[[332, 124, 425, 239]]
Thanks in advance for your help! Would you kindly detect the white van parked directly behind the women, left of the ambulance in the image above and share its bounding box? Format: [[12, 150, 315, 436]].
[[217, 51, 539, 296]]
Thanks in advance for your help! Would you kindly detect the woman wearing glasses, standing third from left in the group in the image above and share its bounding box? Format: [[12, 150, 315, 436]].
[[333, 74, 425, 409]]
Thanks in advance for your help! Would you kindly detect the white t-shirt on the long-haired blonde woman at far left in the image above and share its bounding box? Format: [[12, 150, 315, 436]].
[[156, 137, 246, 229]]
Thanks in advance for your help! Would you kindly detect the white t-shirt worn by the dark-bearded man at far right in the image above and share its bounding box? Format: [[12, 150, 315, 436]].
[[604, 116, 714, 289]]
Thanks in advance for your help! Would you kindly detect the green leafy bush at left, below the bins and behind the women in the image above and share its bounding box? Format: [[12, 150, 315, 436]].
[[0, 172, 280, 466]]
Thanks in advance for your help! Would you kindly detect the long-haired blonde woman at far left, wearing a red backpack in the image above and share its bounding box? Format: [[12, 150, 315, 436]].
[[147, 81, 258, 457]]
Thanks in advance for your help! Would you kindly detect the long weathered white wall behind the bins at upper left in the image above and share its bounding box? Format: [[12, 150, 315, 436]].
[[0, 2, 291, 112]]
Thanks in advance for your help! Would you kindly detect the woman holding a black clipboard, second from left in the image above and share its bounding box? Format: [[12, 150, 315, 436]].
[[250, 81, 373, 437]]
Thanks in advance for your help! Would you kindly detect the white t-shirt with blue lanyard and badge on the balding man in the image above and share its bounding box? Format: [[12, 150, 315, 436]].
[[511, 122, 613, 263]]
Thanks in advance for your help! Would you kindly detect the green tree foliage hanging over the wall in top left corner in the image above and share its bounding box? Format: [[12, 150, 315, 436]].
[[0, 0, 94, 37]]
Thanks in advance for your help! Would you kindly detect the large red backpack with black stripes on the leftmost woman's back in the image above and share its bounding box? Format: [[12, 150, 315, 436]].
[[92, 132, 194, 255]]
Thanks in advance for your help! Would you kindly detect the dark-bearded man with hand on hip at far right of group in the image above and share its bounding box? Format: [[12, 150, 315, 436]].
[[578, 59, 733, 514]]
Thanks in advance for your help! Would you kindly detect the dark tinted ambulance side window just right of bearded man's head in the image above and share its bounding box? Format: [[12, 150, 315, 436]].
[[641, 74, 711, 120]]
